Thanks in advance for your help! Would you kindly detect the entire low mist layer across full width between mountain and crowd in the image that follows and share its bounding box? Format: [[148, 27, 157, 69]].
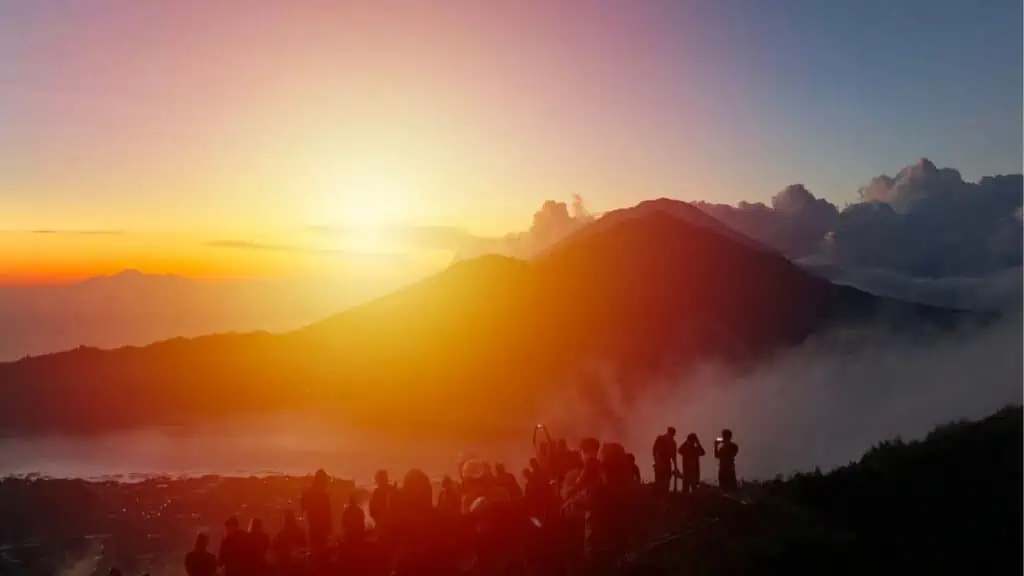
[[0, 310, 1024, 484]]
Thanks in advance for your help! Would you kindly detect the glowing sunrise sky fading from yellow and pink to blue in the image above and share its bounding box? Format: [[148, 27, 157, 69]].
[[0, 0, 1024, 282]]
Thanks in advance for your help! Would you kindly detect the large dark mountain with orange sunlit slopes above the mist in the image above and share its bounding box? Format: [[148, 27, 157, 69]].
[[0, 201, 950, 436]]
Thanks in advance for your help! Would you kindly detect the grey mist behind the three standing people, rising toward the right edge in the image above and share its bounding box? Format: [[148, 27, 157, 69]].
[[548, 311, 1024, 480]]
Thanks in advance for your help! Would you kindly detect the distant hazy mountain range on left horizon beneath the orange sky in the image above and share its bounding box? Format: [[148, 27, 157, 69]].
[[0, 270, 391, 361]]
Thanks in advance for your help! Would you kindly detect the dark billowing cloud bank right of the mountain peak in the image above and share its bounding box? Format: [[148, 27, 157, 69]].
[[695, 159, 1024, 278]]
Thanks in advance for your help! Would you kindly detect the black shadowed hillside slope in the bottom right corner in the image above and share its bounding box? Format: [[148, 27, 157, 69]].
[[621, 407, 1024, 576]]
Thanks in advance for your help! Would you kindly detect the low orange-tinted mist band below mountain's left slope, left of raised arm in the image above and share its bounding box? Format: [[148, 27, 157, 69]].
[[0, 413, 531, 485]]
